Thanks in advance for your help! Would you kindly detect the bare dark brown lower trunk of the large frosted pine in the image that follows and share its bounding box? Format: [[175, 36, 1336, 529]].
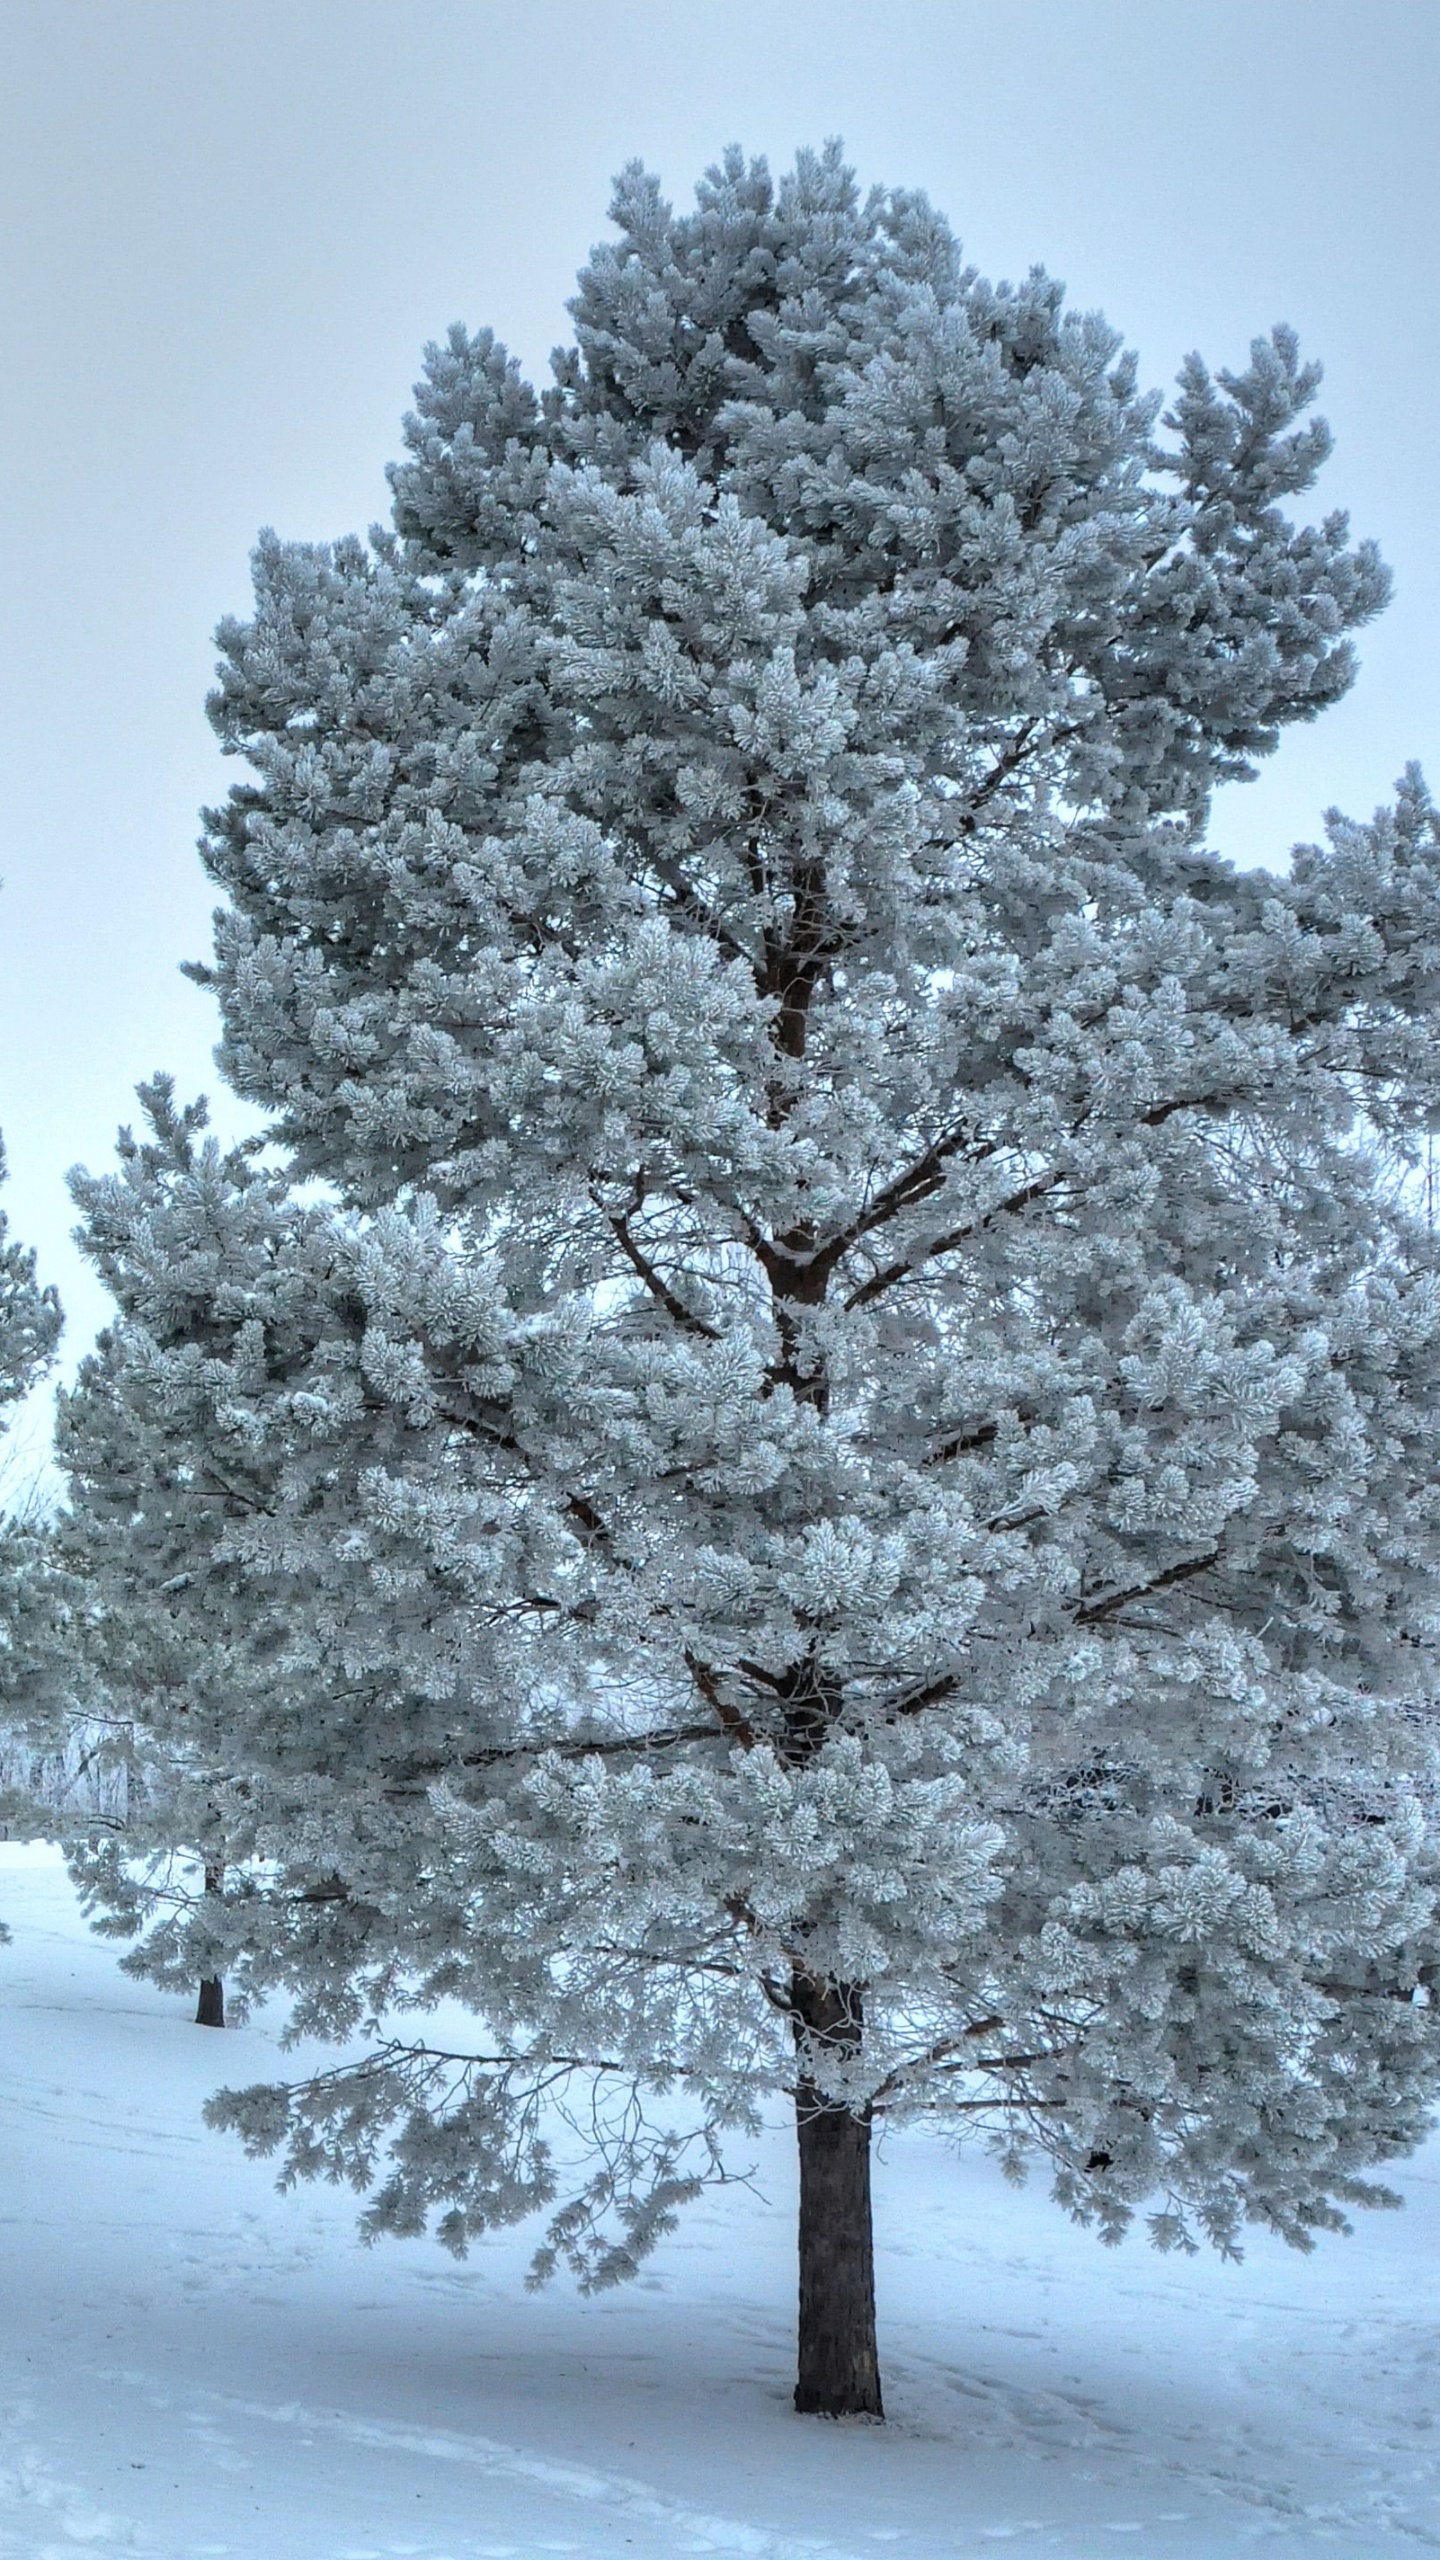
[[794, 1981, 884, 2417]]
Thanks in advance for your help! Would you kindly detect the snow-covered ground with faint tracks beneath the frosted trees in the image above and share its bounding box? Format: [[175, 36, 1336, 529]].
[[0, 1848, 1440, 2560]]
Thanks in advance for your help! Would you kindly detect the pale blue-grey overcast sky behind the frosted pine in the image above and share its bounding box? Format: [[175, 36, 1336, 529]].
[[0, 0, 1440, 1443]]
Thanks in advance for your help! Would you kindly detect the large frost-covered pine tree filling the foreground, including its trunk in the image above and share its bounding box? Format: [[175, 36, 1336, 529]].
[[64, 154, 1440, 2414]]
